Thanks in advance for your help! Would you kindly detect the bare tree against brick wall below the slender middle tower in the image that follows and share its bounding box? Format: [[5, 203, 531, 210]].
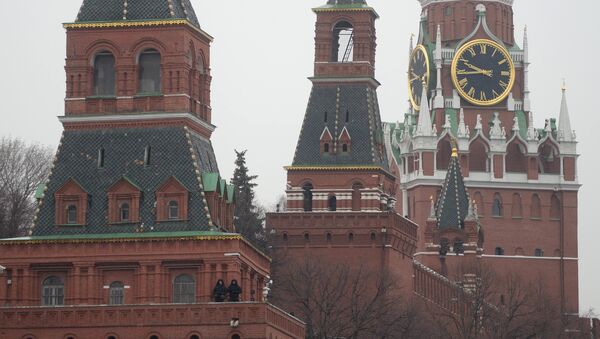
[[271, 256, 420, 339]]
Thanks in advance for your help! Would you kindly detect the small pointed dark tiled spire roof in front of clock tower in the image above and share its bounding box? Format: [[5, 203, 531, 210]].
[[437, 151, 469, 229]]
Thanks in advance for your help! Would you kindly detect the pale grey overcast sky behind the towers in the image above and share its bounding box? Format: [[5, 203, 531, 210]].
[[0, 0, 600, 311]]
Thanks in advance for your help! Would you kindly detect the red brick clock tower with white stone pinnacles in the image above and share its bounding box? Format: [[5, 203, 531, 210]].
[[385, 0, 580, 314]]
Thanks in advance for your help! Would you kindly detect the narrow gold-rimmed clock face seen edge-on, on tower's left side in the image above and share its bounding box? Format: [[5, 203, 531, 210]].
[[408, 45, 429, 111]]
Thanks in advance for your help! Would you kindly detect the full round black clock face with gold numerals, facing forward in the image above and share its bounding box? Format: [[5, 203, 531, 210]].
[[452, 39, 515, 106]]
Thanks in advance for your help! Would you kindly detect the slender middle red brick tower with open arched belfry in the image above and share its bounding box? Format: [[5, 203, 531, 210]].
[[267, 0, 417, 298]]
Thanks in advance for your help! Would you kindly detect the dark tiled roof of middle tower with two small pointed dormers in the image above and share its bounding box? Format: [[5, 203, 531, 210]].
[[293, 85, 388, 169]]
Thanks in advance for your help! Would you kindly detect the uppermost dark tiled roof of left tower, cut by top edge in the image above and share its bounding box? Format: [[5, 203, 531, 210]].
[[76, 0, 200, 28]]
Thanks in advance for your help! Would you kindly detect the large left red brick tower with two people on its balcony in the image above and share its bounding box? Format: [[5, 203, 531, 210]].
[[0, 0, 304, 339]]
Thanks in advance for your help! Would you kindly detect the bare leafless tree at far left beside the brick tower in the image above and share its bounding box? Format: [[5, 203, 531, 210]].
[[0, 138, 52, 238]]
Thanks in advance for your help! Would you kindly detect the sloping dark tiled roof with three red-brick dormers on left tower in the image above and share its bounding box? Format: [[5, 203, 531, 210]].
[[33, 127, 218, 236]]
